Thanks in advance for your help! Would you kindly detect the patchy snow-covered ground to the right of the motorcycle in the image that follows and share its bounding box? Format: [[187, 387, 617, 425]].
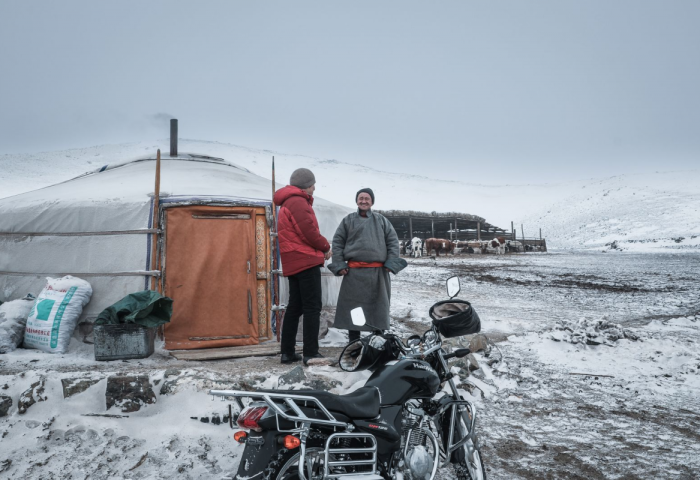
[[395, 253, 700, 479]]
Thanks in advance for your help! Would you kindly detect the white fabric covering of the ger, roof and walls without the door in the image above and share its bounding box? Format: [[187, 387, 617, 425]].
[[0, 153, 350, 319]]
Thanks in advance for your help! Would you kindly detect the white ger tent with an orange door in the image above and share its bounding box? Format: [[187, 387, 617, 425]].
[[0, 153, 350, 348]]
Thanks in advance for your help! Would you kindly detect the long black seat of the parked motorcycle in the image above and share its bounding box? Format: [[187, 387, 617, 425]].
[[258, 387, 379, 419]]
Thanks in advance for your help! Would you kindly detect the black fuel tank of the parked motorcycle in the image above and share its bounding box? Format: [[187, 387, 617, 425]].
[[365, 358, 440, 405]]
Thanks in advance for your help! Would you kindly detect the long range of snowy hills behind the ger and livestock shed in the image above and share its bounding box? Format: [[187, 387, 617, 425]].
[[0, 139, 700, 251]]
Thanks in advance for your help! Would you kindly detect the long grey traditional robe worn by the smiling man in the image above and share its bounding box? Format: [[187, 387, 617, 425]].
[[328, 210, 408, 331]]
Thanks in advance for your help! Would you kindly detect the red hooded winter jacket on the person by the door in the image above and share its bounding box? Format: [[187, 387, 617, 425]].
[[274, 185, 331, 277]]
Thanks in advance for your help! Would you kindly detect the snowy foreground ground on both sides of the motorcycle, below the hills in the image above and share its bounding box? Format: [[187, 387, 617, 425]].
[[0, 252, 700, 480]]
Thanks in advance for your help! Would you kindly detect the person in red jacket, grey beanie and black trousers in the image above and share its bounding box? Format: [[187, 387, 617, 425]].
[[274, 168, 331, 365]]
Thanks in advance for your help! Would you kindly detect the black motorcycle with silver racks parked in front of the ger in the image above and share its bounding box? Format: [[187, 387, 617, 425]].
[[209, 277, 486, 480]]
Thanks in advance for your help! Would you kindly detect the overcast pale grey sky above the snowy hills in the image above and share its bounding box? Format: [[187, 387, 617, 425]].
[[0, 0, 700, 183]]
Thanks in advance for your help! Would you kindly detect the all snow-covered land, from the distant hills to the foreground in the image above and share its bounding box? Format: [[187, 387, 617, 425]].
[[0, 141, 700, 480]]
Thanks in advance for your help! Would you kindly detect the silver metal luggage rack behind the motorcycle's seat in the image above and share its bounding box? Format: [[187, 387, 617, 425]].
[[209, 390, 348, 430]]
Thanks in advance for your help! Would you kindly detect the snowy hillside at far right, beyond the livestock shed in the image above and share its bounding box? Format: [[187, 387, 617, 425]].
[[524, 170, 700, 251]]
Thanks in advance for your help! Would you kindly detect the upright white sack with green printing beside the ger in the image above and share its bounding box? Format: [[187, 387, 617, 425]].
[[24, 275, 92, 353]]
